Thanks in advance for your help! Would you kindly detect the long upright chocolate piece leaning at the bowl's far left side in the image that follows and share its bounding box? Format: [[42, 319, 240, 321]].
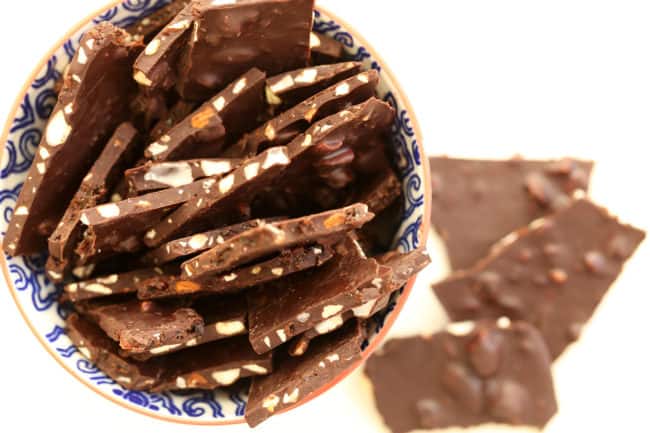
[[4, 23, 140, 256]]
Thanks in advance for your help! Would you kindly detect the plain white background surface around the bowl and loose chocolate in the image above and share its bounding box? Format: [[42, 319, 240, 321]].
[[0, 0, 650, 433]]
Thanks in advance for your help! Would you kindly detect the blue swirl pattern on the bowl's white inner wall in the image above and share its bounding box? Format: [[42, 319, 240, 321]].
[[0, 0, 425, 420]]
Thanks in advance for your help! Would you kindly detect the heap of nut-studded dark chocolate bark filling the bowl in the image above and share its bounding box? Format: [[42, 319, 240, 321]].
[[4, 0, 429, 425]]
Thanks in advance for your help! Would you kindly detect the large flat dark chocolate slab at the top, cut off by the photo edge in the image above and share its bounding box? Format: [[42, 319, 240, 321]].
[[177, 0, 314, 100]]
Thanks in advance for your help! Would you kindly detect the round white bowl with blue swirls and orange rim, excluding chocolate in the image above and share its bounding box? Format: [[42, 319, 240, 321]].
[[0, 0, 431, 425]]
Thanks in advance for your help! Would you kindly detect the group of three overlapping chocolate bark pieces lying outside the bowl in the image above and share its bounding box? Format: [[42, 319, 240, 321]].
[[366, 157, 645, 433]]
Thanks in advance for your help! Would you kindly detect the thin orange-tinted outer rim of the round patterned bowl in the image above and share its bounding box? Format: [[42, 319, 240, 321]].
[[0, 0, 432, 426]]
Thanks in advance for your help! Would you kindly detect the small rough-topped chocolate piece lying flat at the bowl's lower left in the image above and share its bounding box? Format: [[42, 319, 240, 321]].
[[88, 301, 204, 354]]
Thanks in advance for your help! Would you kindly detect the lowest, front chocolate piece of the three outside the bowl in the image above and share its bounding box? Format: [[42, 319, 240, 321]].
[[366, 319, 557, 433]]
